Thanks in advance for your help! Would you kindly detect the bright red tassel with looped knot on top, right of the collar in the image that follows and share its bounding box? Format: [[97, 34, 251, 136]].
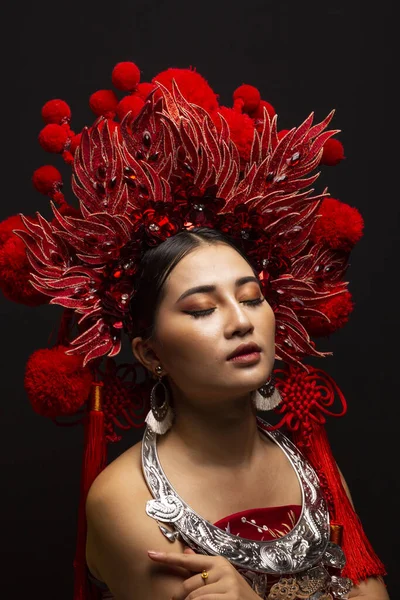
[[270, 365, 386, 584]]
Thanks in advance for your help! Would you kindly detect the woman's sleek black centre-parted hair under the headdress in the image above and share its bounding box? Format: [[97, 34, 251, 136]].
[[130, 227, 254, 340]]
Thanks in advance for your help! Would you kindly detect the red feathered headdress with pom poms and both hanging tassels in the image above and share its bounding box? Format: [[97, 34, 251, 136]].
[[0, 63, 385, 600]]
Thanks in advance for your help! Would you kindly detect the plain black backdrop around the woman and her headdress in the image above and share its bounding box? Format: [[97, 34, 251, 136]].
[[0, 0, 400, 600]]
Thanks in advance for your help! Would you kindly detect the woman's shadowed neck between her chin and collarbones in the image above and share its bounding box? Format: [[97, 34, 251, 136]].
[[159, 386, 263, 470]]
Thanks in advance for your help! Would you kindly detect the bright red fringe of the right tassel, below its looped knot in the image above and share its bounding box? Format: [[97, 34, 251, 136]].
[[293, 423, 386, 584]]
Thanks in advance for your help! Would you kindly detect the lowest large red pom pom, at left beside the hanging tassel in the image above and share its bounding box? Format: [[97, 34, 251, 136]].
[[24, 346, 92, 419]]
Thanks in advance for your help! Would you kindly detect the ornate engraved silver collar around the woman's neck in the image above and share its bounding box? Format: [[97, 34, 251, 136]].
[[142, 418, 331, 574]]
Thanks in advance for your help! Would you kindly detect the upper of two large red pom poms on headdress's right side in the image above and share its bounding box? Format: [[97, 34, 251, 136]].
[[311, 198, 364, 252]]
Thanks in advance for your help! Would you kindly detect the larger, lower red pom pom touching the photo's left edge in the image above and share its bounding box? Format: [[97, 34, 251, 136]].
[[0, 229, 49, 306]]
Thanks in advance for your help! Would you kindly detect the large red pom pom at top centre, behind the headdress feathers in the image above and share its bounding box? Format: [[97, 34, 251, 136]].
[[152, 69, 218, 112]]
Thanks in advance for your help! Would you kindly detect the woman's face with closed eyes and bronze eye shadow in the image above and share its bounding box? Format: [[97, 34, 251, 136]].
[[134, 243, 275, 403]]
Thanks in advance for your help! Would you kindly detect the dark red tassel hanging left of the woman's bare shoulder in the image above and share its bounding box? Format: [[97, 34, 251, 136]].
[[73, 381, 107, 600]]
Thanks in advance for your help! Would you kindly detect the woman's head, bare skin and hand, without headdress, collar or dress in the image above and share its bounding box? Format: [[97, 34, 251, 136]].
[[87, 229, 388, 600]]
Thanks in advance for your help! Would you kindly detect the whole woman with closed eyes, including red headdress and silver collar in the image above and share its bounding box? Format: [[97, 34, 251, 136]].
[[1, 63, 387, 600]]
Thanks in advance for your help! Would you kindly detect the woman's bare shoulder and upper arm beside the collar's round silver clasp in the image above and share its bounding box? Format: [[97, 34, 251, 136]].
[[86, 442, 187, 600]]
